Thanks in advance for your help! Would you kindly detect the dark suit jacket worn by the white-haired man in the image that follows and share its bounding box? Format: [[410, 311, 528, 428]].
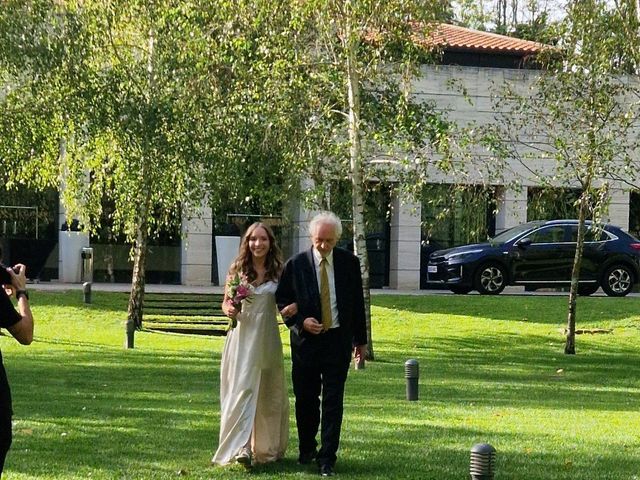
[[276, 248, 367, 362]]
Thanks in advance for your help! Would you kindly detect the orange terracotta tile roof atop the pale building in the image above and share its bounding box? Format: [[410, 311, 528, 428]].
[[430, 23, 545, 55]]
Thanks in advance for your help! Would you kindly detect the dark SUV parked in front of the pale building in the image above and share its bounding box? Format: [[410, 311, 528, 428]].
[[427, 220, 640, 297]]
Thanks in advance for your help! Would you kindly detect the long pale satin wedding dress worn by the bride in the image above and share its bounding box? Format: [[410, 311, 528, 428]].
[[211, 281, 289, 465]]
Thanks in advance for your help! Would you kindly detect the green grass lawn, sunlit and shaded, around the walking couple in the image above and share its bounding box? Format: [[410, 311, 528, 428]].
[[0, 292, 640, 480]]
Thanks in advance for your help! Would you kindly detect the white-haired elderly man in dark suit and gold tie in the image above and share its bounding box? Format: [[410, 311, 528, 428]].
[[276, 212, 367, 477]]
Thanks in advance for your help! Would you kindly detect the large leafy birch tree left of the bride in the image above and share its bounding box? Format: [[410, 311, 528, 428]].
[[0, 0, 304, 347]]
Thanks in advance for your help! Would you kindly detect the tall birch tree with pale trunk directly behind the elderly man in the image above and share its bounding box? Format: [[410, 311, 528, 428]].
[[288, 0, 452, 358]]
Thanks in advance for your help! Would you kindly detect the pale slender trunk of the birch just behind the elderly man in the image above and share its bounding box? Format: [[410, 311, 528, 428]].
[[346, 1, 374, 360]]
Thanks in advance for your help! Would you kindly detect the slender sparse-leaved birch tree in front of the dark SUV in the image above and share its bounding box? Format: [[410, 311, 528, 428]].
[[490, 0, 640, 354]]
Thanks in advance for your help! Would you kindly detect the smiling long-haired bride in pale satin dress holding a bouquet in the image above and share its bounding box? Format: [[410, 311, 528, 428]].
[[212, 223, 297, 467]]
